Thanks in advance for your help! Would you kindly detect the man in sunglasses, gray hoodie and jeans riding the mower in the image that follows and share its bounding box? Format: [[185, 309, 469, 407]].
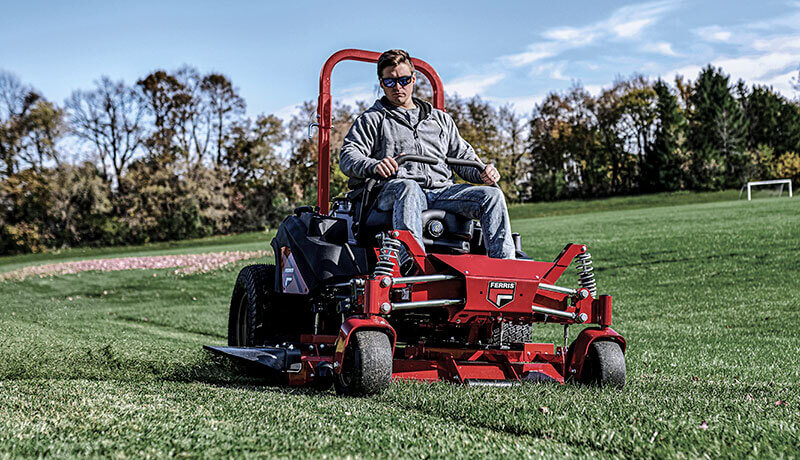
[[339, 50, 515, 259]]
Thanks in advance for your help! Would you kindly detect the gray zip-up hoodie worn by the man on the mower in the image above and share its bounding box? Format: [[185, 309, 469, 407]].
[[339, 97, 483, 188]]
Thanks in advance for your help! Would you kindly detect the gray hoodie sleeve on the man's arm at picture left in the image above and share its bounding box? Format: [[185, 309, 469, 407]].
[[339, 114, 380, 179]]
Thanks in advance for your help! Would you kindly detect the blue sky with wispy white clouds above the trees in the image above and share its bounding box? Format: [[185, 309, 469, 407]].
[[0, 0, 800, 117]]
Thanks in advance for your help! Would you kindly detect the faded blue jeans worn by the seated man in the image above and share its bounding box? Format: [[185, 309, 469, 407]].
[[376, 179, 516, 259]]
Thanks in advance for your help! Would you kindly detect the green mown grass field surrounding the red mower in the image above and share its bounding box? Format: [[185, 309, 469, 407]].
[[0, 192, 800, 458]]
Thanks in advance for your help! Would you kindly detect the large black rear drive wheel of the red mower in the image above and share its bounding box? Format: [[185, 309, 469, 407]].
[[228, 264, 311, 347]]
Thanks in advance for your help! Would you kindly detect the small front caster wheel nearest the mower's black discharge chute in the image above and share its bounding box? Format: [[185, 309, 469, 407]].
[[334, 330, 392, 396]]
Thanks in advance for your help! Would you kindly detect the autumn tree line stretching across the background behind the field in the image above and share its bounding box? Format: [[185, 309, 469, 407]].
[[0, 66, 800, 254]]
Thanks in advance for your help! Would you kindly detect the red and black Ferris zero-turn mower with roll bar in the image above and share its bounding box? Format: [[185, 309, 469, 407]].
[[206, 50, 625, 395]]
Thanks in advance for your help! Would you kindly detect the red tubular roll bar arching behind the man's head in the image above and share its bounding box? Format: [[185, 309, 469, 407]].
[[317, 49, 444, 214]]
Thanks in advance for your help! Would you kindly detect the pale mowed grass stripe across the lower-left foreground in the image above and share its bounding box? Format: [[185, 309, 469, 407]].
[[0, 381, 575, 458]]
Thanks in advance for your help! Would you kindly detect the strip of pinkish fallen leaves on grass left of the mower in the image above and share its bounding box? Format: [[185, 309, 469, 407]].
[[0, 251, 271, 281]]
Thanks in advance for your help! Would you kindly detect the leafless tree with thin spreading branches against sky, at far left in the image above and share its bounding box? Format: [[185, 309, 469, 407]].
[[66, 77, 144, 188]]
